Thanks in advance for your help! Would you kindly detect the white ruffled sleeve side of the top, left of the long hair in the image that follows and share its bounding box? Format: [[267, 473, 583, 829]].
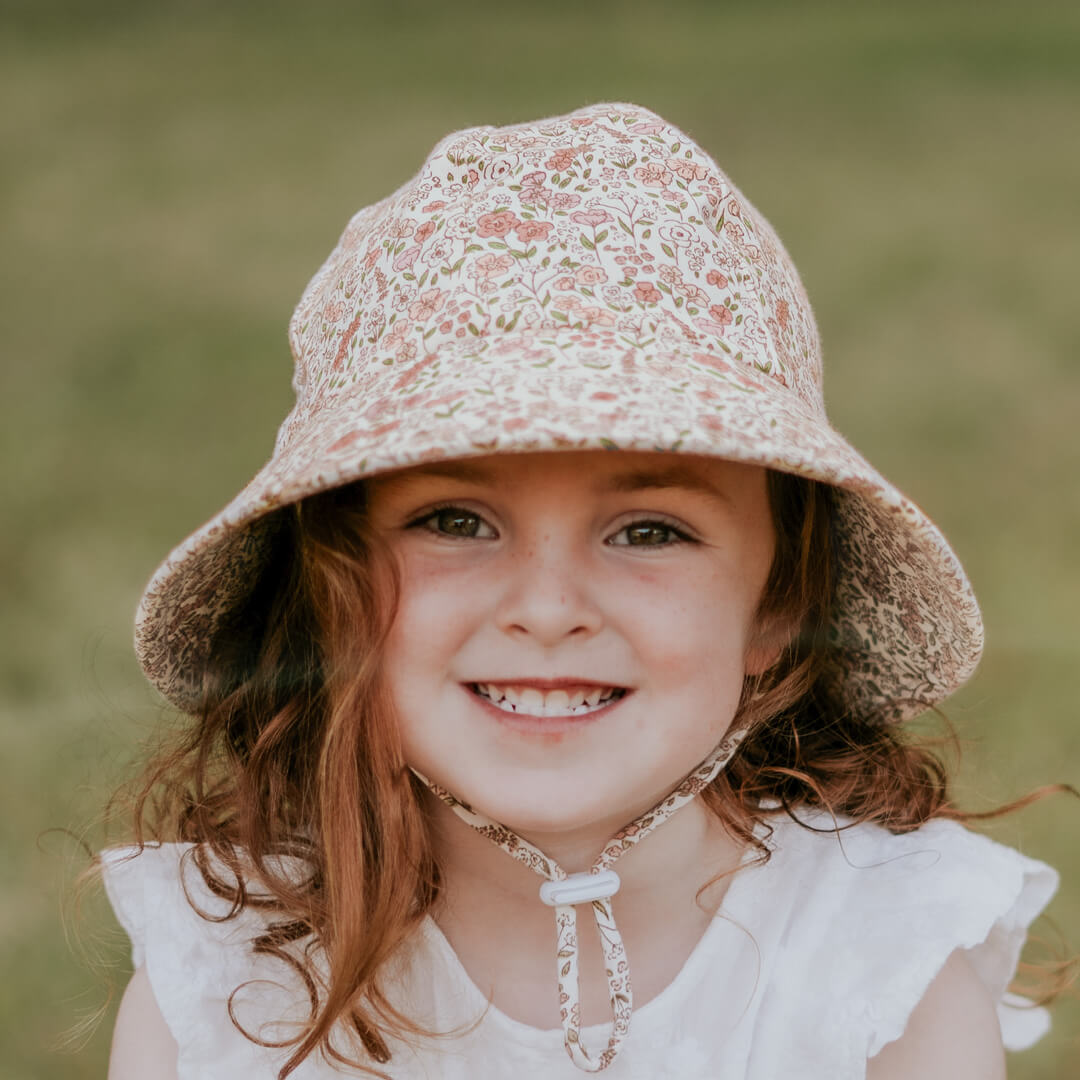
[[100, 843, 315, 1080]]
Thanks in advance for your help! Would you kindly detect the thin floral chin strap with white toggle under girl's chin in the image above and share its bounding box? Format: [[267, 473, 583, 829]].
[[413, 731, 746, 1072]]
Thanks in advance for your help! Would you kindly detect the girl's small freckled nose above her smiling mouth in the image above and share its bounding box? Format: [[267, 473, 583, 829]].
[[496, 534, 604, 646]]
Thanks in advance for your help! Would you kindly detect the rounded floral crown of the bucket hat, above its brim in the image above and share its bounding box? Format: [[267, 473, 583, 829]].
[[280, 105, 824, 453]]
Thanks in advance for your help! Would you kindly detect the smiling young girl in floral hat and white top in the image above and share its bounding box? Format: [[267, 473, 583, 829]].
[[103, 105, 1055, 1080]]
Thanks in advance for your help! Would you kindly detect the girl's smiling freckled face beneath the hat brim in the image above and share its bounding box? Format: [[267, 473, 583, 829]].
[[368, 451, 779, 839]]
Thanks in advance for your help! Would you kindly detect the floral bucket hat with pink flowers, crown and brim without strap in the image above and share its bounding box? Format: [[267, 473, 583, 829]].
[[135, 104, 982, 721]]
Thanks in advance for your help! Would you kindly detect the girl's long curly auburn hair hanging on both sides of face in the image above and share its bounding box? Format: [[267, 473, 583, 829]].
[[107, 471, 1062, 1080]]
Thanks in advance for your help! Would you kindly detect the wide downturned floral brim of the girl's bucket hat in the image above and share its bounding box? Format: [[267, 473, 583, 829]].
[[135, 334, 983, 720]]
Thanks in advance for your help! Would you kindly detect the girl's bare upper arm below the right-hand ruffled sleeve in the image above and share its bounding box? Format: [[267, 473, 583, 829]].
[[866, 953, 1005, 1080]]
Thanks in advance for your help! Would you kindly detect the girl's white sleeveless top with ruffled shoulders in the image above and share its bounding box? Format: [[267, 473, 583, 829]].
[[103, 815, 1057, 1080]]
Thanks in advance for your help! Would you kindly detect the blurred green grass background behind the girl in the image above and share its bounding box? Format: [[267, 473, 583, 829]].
[[0, 0, 1080, 1080]]
